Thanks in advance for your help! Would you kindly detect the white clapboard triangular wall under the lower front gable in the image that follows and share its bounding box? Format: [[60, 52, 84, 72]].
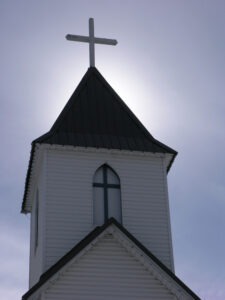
[[43, 234, 177, 300]]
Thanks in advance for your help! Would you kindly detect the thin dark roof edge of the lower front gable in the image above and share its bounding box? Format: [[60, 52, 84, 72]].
[[22, 218, 200, 300]]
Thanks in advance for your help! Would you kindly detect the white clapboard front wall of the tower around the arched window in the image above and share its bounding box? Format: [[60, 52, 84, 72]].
[[44, 149, 173, 270]]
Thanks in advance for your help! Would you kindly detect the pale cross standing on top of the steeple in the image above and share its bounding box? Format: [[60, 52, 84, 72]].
[[66, 18, 117, 67]]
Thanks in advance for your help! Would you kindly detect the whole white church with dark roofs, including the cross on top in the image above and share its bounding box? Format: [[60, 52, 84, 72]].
[[22, 19, 200, 300]]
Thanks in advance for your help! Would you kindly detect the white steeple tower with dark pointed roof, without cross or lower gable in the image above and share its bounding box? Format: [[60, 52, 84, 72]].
[[22, 67, 176, 285]]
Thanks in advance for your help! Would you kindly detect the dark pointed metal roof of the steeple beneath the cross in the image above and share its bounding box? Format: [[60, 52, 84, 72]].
[[34, 67, 176, 155]]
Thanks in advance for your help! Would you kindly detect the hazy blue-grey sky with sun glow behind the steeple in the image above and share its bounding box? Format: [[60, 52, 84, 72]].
[[0, 0, 225, 300]]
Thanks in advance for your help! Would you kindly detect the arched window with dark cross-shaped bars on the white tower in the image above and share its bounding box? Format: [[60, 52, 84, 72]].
[[93, 165, 122, 225]]
